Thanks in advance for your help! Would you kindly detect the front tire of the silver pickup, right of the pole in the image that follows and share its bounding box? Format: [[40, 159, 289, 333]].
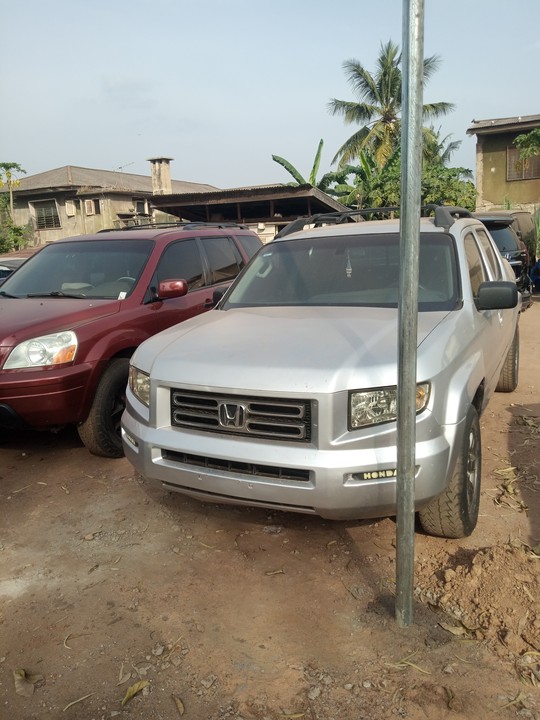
[[418, 405, 482, 538]]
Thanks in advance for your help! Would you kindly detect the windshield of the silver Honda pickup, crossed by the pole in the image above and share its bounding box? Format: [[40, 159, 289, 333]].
[[223, 233, 460, 310]]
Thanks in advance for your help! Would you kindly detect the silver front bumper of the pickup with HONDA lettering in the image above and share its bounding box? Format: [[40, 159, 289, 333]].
[[122, 411, 461, 520]]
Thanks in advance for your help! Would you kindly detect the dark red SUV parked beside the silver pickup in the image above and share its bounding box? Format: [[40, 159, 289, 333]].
[[0, 223, 261, 457]]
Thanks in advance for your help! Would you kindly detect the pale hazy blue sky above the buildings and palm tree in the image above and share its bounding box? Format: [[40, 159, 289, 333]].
[[0, 0, 540, 188]]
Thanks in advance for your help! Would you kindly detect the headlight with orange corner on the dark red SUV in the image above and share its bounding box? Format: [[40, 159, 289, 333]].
[[4, 330, 77, 370]]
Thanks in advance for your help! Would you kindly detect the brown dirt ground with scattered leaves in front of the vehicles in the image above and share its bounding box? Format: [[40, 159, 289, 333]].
[[0, 297, 540, 720]]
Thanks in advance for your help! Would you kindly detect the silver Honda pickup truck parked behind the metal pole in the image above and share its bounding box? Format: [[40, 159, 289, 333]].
[[122, 207, 521, 538]]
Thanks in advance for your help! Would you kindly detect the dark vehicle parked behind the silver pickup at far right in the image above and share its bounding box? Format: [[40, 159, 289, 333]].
[[474, 212, 532, 310]]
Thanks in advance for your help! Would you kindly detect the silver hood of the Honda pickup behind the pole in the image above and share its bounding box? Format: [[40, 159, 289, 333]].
[[133, 307, 448, 393]]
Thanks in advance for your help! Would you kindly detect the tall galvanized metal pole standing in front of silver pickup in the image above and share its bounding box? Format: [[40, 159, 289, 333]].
[[396, 0, 424, 627]]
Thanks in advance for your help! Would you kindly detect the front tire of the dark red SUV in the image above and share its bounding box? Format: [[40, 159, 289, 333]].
[[77, 358, 129, 458]]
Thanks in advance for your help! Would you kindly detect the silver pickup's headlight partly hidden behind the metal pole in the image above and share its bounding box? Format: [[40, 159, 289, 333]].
[[349, 383, 430, 430]]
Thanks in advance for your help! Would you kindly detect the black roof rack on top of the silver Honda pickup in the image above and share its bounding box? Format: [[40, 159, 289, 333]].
[[276, 204, 474, 238]]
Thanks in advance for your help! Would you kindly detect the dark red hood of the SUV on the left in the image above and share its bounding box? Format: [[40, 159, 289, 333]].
[[0, 297, 120, 347]]
